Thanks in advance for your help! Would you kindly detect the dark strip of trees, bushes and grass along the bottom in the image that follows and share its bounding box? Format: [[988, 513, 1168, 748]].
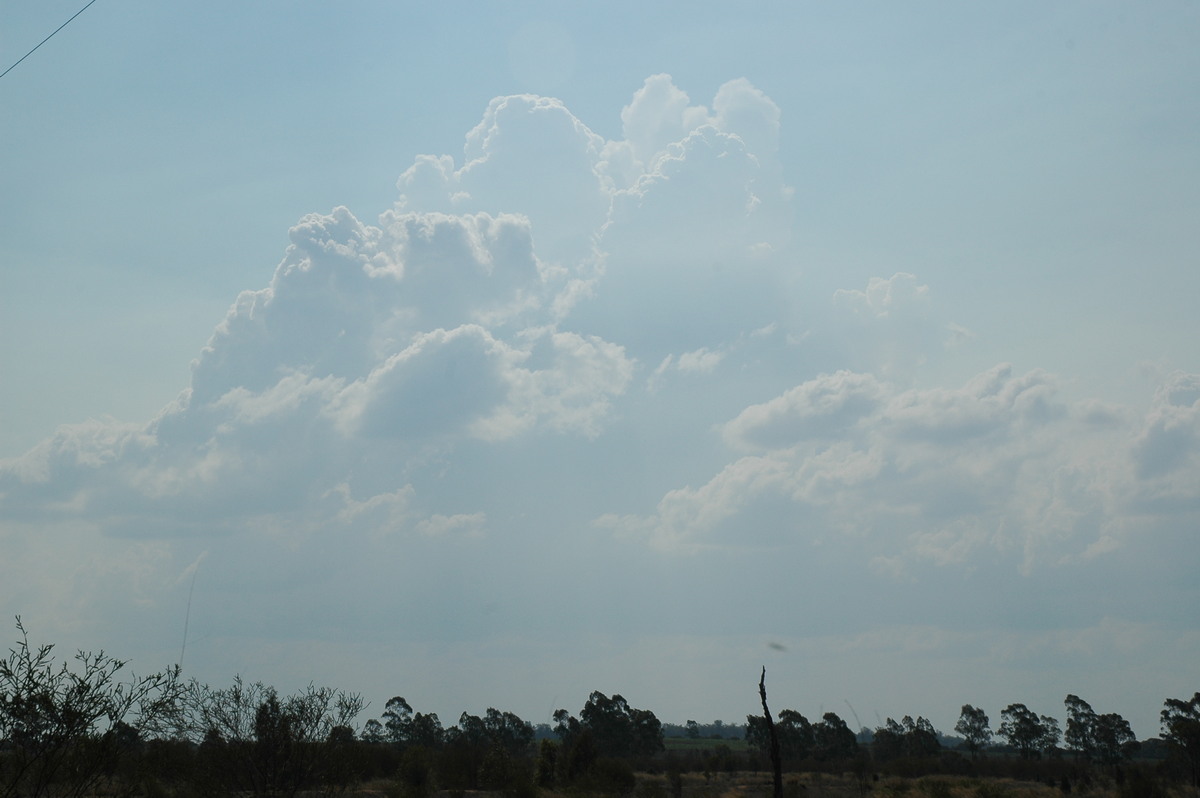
[[0, 618, 1200, 798]]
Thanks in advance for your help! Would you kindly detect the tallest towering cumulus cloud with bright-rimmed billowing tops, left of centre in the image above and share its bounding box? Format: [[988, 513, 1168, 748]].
[[0, 76, 801, 544]]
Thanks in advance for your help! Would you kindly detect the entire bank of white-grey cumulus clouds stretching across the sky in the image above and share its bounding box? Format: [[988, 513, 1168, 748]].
[[0, 74, 1200, 686]]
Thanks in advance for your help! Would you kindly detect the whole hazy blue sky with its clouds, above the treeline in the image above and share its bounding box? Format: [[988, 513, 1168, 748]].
[[0, 0, 1200, 738]]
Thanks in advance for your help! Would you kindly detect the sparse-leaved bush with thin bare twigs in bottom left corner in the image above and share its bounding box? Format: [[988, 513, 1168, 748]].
[[0, 616, 181, 798]]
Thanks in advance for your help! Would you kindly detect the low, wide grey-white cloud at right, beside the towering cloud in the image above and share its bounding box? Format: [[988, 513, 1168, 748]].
[[609, 365, 1198, 576]]
